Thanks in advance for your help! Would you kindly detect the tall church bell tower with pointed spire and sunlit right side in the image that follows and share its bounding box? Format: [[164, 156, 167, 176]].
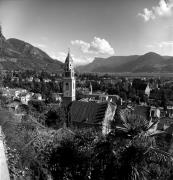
[[63, 51, 76, 106]]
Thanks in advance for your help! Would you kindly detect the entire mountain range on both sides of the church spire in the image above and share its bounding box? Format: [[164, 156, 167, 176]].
[[0, 31, 173, 73]]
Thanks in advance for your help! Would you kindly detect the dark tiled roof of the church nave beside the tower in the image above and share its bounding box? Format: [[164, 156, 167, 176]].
[[70, 101, 108, 124]]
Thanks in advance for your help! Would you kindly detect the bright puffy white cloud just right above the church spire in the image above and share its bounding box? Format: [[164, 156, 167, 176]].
[[71, 37, 115, 55]]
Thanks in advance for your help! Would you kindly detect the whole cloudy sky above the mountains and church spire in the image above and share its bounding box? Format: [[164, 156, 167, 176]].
[[0, 0, 173, 65]]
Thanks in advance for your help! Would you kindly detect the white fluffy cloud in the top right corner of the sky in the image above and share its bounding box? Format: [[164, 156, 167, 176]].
[[138, 0, 173, 21]]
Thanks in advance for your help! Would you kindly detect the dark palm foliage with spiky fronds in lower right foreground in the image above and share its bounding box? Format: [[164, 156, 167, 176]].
[[91, 114, 172, 180]]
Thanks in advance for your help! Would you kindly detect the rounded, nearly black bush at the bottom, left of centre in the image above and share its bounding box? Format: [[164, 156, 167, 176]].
[[49, 140, 88, 180]]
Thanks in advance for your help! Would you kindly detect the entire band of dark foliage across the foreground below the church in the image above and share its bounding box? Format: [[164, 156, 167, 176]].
[[0, 109, 173, 180]]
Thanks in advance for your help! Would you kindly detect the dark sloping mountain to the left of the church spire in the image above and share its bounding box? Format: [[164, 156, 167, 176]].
[[0, 33, 63, 72]]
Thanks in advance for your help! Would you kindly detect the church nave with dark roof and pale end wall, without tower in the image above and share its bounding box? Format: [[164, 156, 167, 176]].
[[70, 101, 117, 135]]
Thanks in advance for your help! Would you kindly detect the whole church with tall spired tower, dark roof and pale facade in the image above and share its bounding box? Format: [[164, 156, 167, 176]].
[[63, 52, 117, 134]]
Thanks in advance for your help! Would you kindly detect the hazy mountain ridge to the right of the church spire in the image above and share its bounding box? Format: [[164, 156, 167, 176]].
[[77, 52, 173, 73]]
